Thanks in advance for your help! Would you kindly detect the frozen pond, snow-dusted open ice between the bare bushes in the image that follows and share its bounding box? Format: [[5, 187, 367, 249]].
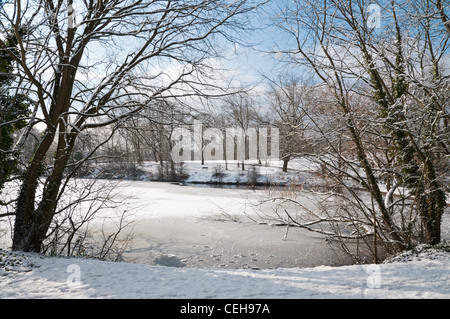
[[105, 182, 448, 269]]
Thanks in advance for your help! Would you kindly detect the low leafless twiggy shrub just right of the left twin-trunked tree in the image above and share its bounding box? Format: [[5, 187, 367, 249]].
[[42, 179, 134, 261]]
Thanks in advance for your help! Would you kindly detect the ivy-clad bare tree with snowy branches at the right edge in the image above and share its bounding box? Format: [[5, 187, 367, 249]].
[[268, 0, 449, 261]]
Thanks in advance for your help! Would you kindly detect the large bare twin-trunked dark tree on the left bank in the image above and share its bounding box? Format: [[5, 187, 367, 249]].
[[0, 0, 262, 252]]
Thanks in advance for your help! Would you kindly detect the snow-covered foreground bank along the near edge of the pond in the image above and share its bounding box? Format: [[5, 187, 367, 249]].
[[0, 245, 450, 299]]
